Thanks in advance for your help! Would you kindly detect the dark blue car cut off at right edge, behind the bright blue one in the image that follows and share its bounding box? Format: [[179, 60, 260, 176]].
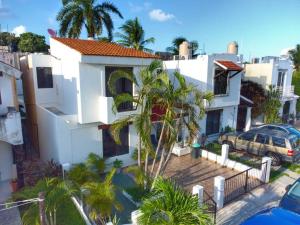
[[279, 178, 300, 215]]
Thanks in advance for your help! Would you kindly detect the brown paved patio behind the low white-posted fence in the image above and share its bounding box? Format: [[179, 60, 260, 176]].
[[158, 154, 239, 196]]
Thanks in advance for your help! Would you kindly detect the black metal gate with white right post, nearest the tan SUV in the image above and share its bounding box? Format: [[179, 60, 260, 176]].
[[224, 162, 267, 205]]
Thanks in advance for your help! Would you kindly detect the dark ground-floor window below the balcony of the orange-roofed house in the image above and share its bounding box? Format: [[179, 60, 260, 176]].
[[102, 126, 129, 158]]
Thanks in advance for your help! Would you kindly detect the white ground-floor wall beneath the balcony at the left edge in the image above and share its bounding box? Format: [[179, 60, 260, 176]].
[[0, 141, 13, 181]]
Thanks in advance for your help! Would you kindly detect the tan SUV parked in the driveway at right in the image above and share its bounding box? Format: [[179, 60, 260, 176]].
[[219, 128, 300, 166]]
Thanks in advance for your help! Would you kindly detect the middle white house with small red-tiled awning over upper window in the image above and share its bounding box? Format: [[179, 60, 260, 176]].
[[164, 42, 246, 137]]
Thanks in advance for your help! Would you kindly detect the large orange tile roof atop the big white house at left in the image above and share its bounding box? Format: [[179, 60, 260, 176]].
[[53, 37, 159, 59]]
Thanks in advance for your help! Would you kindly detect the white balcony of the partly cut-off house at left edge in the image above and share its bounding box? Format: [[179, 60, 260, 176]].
[[0, 112, 23, 145]]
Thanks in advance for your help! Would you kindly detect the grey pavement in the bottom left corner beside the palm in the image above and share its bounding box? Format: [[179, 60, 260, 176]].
[[0, 181, 22, 225]]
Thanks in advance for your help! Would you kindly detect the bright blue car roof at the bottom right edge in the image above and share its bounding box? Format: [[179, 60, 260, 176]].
[[240, 207, 300, 225]]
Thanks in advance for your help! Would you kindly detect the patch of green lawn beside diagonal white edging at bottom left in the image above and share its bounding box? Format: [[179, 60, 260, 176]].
[[20, 199, 85, 225]]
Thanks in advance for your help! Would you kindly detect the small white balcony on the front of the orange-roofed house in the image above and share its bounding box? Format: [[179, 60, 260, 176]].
[[99, 96, 138, 124]]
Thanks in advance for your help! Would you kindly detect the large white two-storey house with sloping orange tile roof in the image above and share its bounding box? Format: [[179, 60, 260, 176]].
[[21, 38, 157, 166]]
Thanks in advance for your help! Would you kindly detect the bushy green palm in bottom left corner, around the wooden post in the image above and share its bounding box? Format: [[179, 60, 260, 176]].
[[13, 178, 75, 225]]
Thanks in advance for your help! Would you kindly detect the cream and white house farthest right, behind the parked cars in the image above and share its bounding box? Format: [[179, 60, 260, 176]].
[[245, 56, 299, 123]]
